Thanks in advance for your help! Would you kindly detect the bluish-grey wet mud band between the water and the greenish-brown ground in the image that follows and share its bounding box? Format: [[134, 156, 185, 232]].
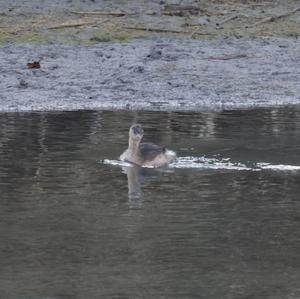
[[0, 38, 300, 111]]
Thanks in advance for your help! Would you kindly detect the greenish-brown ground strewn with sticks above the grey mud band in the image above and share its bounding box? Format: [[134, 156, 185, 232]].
[[0, 0, 300, 44]]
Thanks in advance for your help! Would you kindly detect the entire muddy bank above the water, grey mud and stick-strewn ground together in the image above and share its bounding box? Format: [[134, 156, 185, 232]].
[[0, 0, 300, 112]]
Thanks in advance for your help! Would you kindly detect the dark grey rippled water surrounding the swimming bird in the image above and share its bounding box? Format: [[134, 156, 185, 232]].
[[0, 106, 300, 299]]
